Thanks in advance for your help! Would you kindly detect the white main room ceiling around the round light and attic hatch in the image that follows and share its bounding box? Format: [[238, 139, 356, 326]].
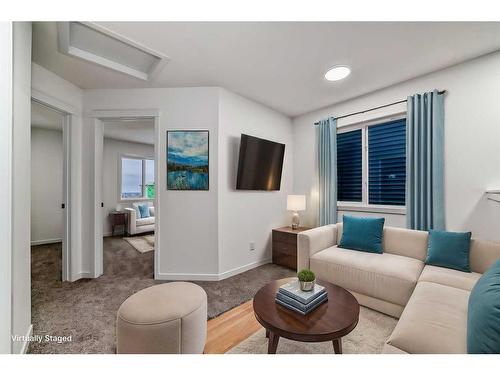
[[33, 22, 500, 116]]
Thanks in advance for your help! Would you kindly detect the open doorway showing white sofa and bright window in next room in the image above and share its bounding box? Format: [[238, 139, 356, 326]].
[[92, 110, 160, 278]]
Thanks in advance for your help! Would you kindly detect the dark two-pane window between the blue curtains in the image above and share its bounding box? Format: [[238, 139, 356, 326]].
[[337, 118, 406, 206]]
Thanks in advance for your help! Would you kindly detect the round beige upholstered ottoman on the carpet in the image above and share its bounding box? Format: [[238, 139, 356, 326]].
[[116, 282, 207, 354]]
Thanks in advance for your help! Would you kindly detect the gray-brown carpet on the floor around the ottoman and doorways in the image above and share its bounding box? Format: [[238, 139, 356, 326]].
[[29, 237, 293, 353]]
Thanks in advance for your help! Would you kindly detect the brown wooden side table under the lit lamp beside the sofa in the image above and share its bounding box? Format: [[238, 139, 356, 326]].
[[273, 227, 311, 271]]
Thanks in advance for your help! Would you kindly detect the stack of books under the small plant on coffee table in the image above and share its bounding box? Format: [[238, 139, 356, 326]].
[[276, 280, 328, 315]]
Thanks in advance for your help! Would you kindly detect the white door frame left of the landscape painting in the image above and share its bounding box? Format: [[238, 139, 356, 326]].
[[89, 109, 162, 279]]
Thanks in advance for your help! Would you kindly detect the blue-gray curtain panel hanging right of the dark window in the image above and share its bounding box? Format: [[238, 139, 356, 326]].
[[406, 90, 445, 230]]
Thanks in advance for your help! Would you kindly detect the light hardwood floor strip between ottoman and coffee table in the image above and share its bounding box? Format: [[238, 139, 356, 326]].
[[204, 300, 262, 354]]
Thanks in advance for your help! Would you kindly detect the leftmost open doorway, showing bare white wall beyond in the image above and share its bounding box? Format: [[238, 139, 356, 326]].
[[31, 99, 71, 281]]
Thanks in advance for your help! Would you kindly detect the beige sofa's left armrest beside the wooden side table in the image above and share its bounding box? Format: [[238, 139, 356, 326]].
[[297, 224, 337, 271]]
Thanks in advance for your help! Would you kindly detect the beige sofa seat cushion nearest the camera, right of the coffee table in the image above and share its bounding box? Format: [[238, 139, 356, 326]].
[[387, 281, 470, 354]]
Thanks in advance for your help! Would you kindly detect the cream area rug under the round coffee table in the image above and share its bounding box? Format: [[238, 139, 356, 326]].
[[227, 306, 397, 354]]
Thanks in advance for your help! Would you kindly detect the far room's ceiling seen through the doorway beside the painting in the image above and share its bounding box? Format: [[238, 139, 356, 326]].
[[103, 120, 155, 145]]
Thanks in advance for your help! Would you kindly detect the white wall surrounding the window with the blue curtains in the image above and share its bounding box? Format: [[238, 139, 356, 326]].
[[293, 53, 500, 240]]
